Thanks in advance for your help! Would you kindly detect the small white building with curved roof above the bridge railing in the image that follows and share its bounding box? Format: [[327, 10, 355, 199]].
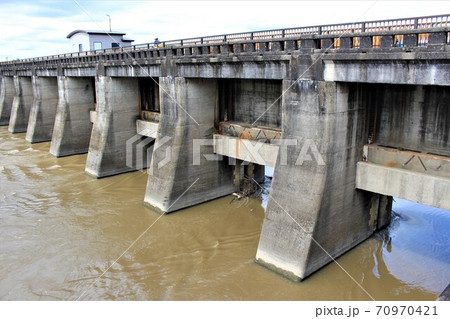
[[67, 30, 134, 52]]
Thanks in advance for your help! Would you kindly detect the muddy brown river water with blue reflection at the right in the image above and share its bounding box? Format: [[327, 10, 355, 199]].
[[0, 127, 450, 300]]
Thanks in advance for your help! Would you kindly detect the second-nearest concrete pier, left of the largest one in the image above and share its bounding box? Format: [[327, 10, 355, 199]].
[[144, 77, 235, 213]]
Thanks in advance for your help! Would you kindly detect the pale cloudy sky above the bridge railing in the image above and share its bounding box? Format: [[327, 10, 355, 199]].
[[0, 0, 450, 61]]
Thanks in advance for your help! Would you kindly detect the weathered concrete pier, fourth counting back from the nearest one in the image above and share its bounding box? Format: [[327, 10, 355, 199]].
[[50, 76, 95, 157]]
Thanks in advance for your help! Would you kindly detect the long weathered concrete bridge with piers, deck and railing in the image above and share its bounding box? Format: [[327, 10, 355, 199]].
[[0, 15, 450, 280]]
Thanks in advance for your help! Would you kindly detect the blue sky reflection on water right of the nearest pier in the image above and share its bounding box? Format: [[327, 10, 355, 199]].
[[382, 199, 450, 295]]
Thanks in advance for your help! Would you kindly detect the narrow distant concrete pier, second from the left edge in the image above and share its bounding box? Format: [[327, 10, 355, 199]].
[[8, 76, 33, 133]]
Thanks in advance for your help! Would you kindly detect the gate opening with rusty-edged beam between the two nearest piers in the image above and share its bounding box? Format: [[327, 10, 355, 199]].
[[214, 79, 282, 198]]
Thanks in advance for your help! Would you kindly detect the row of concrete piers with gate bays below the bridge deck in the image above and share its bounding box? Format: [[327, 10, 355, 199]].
[[0, 67, 450, 280]]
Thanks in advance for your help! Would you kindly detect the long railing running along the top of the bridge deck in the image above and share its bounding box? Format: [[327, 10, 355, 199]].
[[0, 14, 450, 64]]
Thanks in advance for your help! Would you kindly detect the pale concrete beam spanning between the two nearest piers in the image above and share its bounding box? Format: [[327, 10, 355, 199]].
[[214, 134, 279, 167]]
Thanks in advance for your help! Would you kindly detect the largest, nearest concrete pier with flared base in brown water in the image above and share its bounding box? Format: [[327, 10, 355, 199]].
[[256, 80, 386, 280]]
